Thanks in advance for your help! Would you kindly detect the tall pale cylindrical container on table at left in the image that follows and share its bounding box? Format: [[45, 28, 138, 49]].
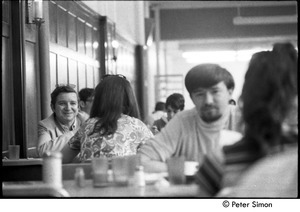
[[43, 151, 62, 188]]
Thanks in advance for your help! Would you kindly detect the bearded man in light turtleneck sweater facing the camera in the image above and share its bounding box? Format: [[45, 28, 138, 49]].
[[139, 64, 241, 172]]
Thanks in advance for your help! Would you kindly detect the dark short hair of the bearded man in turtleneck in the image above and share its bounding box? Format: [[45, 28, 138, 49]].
[[185, 63, 235, 94]]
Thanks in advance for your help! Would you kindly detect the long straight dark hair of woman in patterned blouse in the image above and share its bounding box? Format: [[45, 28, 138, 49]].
[[90, 75, 140, 135]]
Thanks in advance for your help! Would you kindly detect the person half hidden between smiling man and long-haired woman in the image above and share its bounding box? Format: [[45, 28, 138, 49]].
[[78, 88, 94, 118]]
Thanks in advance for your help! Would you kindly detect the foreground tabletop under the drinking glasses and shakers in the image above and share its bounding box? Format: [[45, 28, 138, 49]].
[[2, 175, 207, 198]]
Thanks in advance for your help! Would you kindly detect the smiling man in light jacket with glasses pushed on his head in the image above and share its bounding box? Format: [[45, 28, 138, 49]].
[[37, 85, 86, 157]]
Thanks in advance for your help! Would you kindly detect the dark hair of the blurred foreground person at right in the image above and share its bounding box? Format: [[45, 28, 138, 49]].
[[240, 43, 298, 155]]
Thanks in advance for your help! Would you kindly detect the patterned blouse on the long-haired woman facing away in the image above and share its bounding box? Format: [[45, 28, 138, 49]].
[[69, 114, 153, 162]]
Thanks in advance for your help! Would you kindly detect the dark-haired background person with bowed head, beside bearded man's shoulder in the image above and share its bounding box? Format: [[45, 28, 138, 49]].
[[152, 93, 184, 134]]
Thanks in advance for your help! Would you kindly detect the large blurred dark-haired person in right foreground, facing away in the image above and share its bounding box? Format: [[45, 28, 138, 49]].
[[219, 43, 298, 198]]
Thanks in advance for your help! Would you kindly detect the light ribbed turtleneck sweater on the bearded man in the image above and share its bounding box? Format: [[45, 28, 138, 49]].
[[139, 107, 239, 166]]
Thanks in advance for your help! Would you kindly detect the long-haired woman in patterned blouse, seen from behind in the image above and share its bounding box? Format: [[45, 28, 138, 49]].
[[62, 75, 153, 163]]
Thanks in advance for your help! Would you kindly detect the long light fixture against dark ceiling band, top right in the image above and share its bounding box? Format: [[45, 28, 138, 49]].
[[233, 15, 298, 25]]
